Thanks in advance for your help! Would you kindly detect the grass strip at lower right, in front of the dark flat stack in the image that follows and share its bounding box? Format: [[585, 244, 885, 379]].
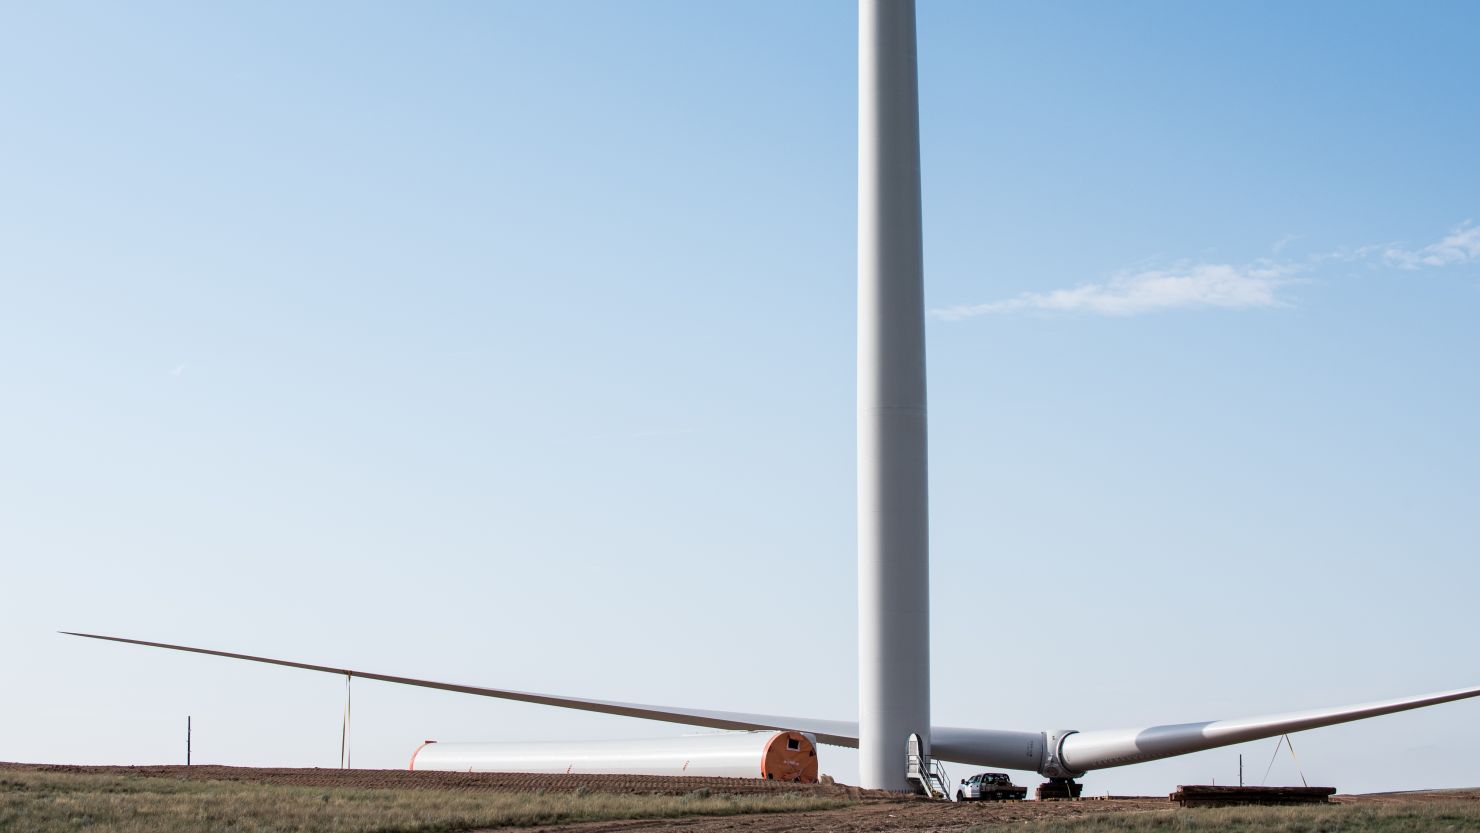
[[971, 800, 1480, 833]]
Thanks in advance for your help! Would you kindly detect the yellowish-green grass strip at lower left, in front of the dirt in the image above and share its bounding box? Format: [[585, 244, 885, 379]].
[[0, 772, 848, 833]]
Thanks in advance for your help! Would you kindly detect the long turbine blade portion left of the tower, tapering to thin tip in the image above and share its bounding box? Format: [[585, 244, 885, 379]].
[[62, 630, 858, 746]]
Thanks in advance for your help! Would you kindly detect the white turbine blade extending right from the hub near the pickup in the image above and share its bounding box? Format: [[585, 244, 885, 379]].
[[1061, 687, 1480, 772]]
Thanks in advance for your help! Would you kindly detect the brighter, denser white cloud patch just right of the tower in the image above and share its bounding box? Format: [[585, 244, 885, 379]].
[[931, 262, 1298, 321]]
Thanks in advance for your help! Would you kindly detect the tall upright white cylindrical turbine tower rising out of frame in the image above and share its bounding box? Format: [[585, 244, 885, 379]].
[[858, 0, 929, 790]]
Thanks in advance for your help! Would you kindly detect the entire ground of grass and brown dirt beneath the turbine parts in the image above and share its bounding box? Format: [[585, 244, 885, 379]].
[[0, 765, 1480, 833]]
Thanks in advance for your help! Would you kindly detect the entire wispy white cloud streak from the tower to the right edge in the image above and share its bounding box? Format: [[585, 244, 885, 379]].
[[931, 220, 1480, 321]]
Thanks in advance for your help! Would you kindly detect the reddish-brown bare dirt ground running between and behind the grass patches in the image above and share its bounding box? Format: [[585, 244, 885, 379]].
[[0, 763, 1480, 833]]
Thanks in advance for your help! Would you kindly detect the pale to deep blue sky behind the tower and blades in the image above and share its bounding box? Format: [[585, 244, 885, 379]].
[[0, 1, 1480, 793]]
